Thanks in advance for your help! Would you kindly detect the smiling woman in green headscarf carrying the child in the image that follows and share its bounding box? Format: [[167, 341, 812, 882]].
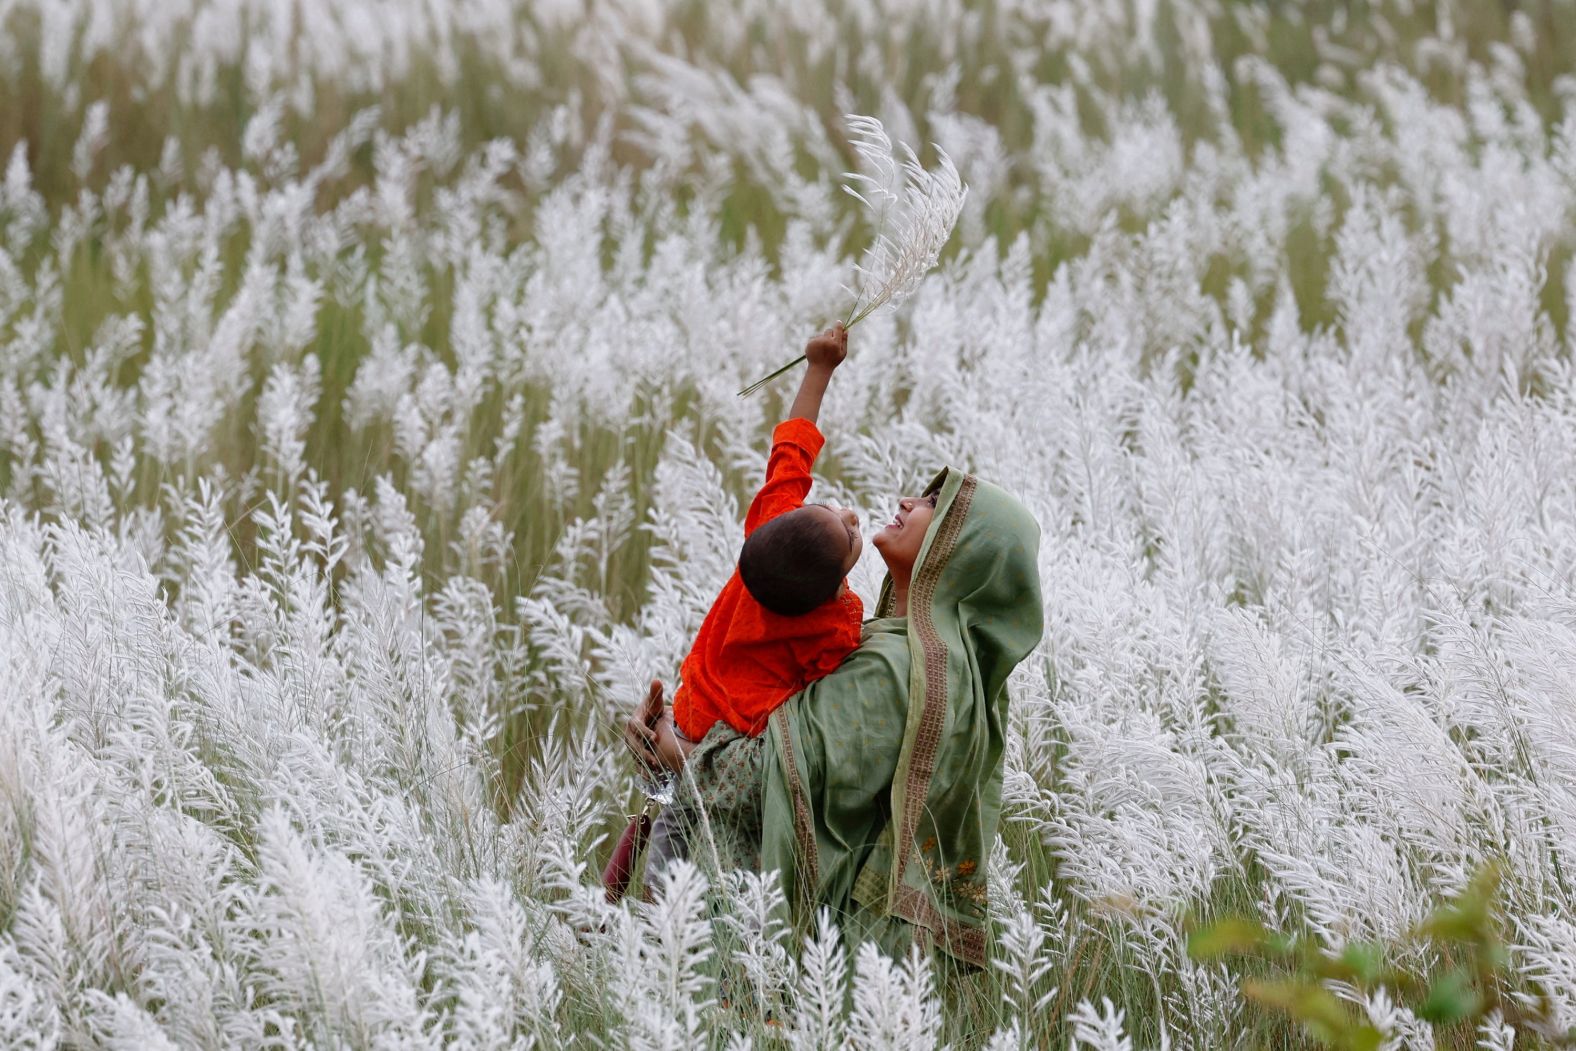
[[626, 468, 1043, 966]]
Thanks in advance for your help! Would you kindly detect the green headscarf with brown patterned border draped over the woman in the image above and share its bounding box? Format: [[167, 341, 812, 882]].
[[761, 468, 1043, 964]]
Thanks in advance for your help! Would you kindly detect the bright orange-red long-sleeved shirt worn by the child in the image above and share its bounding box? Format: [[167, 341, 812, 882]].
[[673, 419, 865, 741]]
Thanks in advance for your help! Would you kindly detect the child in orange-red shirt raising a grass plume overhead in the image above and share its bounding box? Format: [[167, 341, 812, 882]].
[[673, 325, 864, 742]]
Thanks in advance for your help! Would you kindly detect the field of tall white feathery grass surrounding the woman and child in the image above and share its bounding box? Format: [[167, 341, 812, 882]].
[[0, 0, 1576, 1048]]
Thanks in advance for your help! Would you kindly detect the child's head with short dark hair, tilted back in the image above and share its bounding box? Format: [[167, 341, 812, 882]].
[[739, 504, 864, 616]]
